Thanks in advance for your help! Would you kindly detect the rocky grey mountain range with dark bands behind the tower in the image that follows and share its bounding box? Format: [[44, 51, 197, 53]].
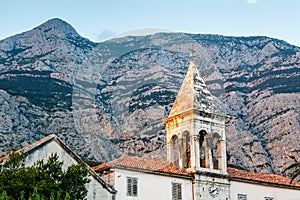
[[0, 19, 300, 173]]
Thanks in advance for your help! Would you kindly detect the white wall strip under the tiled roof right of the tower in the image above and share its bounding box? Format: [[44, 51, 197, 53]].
[[230, 181, 300, 200]]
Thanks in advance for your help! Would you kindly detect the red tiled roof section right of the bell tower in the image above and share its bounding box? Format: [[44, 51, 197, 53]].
[[227, 168, 300, 187]]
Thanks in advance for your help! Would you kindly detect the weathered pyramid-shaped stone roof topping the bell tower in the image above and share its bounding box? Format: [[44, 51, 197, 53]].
[[169, 60, 217, 117]]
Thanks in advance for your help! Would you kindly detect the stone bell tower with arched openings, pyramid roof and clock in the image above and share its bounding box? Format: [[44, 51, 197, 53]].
[[164, 57, 229, 200]]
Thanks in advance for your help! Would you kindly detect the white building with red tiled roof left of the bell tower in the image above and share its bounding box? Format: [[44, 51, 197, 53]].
[[93, 157, 193, 200]]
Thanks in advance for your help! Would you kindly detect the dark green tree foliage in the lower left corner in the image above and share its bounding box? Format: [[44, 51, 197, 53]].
[[0, 153, 90, 200]]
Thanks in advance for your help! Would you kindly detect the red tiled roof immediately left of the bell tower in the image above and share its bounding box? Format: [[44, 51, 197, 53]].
[[92, 156, 190, 176]]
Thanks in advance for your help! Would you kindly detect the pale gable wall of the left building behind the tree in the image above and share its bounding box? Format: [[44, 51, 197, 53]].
[[25, 140, 113, 200]]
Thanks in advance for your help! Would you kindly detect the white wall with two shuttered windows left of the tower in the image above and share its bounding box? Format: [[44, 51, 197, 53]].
[[114, 169, 193, 200]]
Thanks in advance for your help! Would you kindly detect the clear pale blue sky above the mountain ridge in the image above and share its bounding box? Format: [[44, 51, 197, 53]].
[[0, 0, 300, 46]]
